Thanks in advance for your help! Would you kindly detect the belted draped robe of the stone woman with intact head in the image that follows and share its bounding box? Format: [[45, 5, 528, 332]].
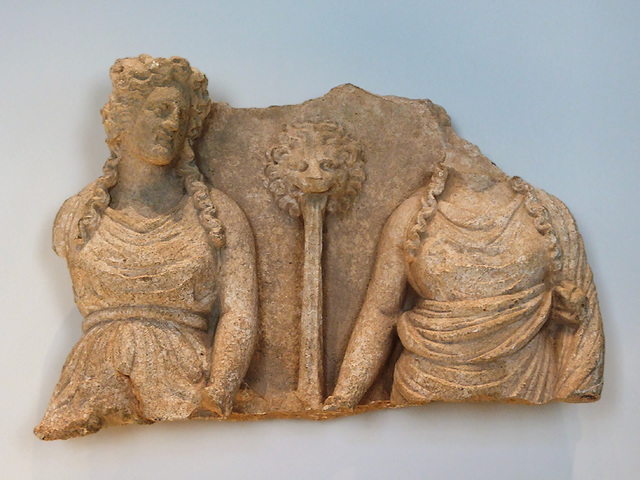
[[37, 192, 218, 436]]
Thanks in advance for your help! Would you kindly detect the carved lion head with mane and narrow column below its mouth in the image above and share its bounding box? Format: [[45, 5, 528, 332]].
[[265, 122, 364, 409]]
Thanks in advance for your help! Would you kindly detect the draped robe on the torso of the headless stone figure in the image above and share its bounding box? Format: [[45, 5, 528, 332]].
[[391, 178, 604, 404]]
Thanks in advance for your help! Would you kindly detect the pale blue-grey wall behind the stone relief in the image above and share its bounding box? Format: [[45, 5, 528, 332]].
[[0, 0, 640, 479]]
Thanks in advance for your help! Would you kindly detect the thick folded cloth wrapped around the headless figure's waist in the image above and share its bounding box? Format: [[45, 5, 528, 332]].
[[392, 284, 555, 404]]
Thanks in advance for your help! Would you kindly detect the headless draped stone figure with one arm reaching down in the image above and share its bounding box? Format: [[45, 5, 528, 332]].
[[325, 137, 604, 410]]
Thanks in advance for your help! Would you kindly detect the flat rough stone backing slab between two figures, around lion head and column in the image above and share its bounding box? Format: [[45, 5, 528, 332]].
[[198, 85, 449, 408]]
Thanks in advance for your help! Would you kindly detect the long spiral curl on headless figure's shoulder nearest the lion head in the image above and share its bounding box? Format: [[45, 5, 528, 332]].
[[405, 161, 449, 265]]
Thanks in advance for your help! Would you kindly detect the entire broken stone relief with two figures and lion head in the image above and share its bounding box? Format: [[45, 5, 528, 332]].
[[36, 56, 604, 439]]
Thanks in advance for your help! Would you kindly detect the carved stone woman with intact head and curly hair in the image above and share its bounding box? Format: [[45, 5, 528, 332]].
[[35, 55, 257, 440]]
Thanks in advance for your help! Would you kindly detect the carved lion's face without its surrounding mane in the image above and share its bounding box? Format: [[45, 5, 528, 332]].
[[273, 143, 348, 194]]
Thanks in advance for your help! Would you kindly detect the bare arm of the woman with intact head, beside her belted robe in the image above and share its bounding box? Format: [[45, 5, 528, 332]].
[[205, 192, 258, 416]]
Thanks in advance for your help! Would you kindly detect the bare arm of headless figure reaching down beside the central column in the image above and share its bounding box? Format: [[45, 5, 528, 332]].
[[325, 197, 418, 409]]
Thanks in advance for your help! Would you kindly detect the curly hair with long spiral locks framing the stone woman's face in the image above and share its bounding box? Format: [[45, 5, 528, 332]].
[[75, 55, 225, 249]]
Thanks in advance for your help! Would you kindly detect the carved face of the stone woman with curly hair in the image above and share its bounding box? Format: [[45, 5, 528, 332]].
[[126, 87, 189, 166]]
